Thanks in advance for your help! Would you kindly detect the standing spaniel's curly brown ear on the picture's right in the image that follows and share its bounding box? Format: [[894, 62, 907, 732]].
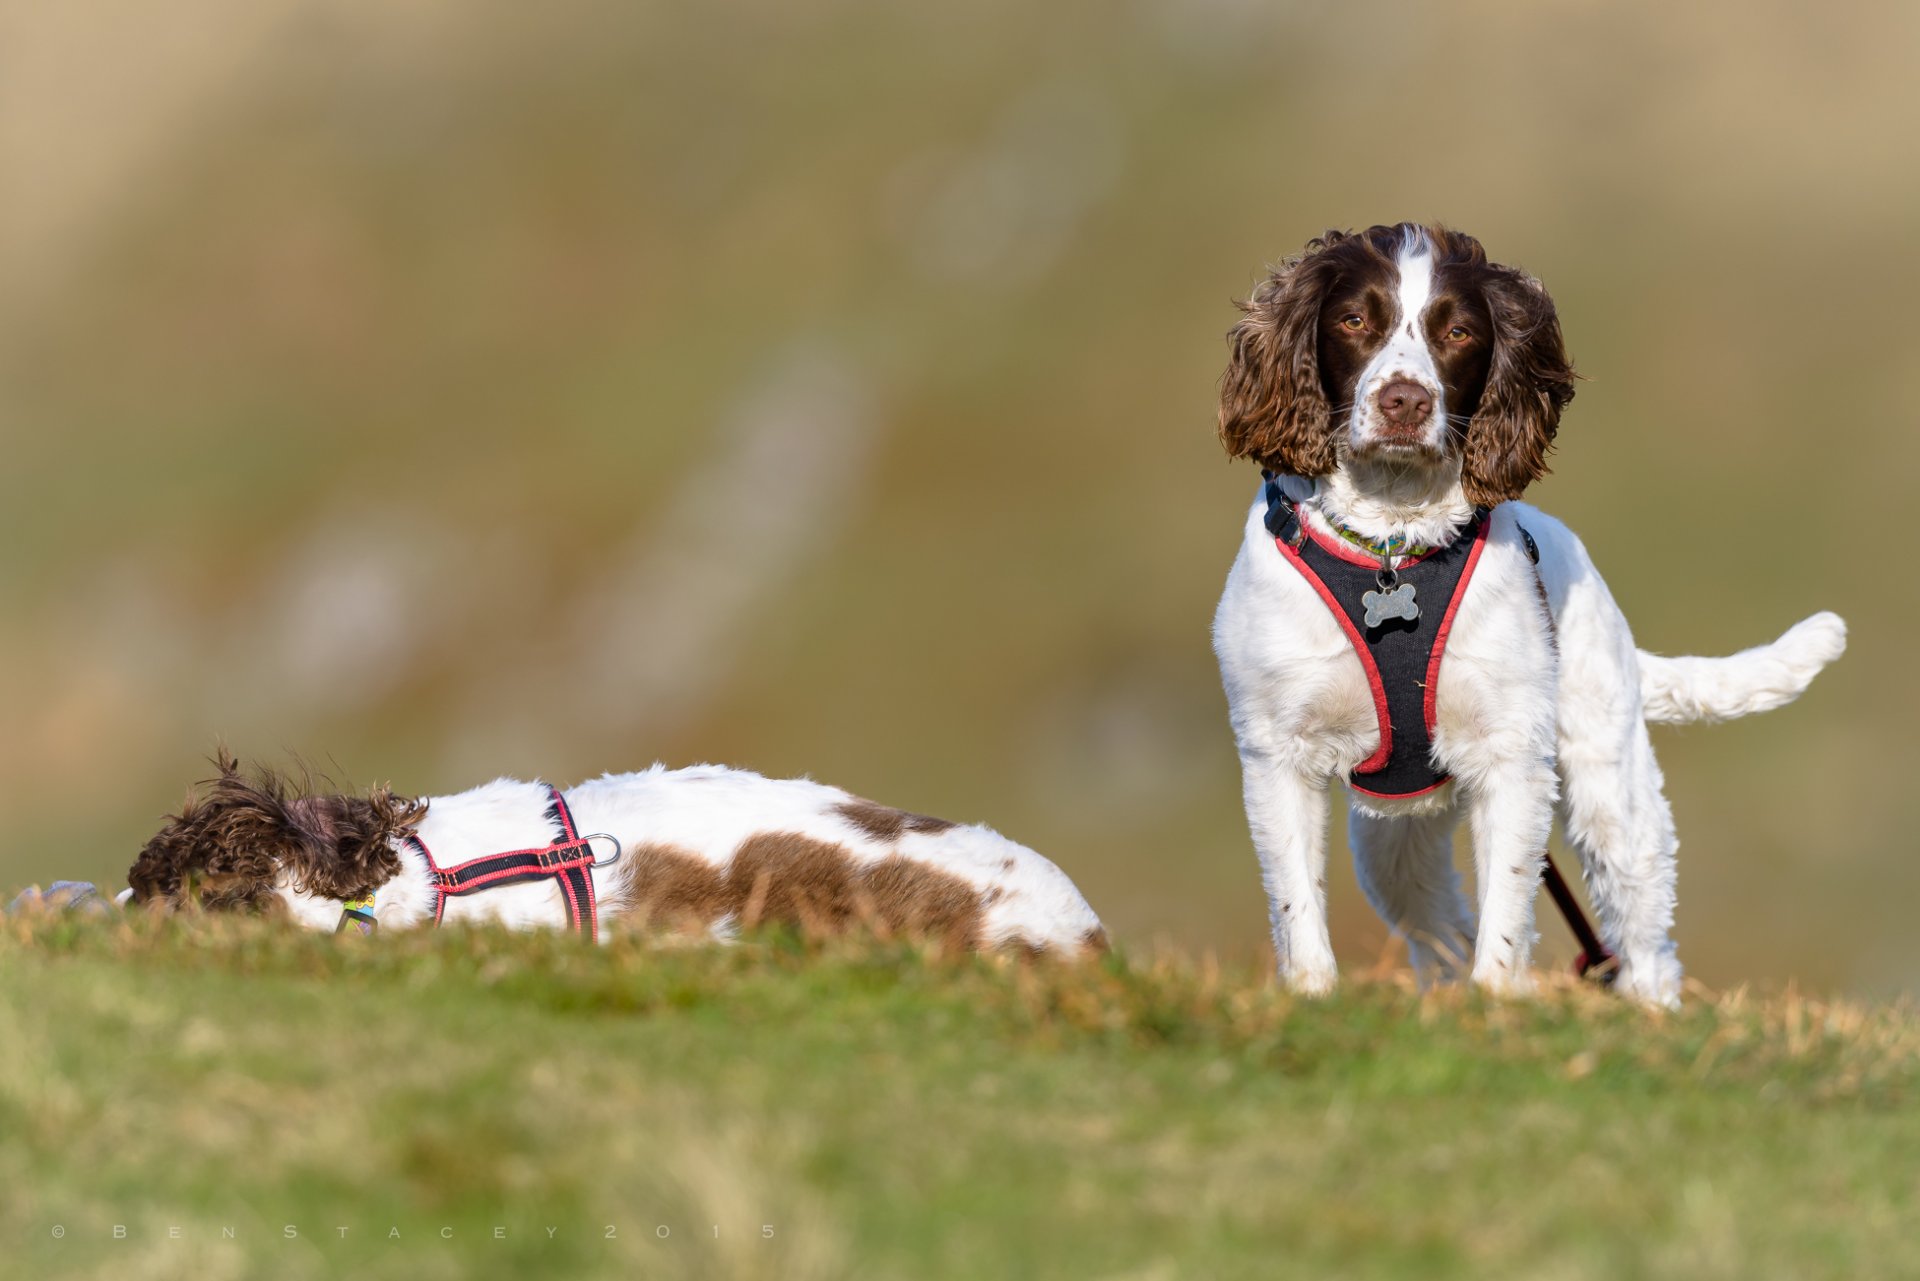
[[1461, 267, 1574, 507]]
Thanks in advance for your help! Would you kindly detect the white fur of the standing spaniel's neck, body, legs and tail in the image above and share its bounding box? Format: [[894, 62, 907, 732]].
[[1213, 485, 1845, 1004]]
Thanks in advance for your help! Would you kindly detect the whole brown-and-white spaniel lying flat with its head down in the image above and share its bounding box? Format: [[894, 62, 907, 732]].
[[121, 751, 1106, 953]]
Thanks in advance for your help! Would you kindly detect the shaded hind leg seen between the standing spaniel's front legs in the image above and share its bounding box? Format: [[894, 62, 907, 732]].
[[1346, 805, 1475, 985]]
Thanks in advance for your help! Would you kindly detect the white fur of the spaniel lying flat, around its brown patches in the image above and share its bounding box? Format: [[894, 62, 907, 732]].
[[280, 764, 1100, 951]]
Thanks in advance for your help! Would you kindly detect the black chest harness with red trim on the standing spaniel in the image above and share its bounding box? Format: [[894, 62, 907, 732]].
[[1267, 478, 1488, 797]]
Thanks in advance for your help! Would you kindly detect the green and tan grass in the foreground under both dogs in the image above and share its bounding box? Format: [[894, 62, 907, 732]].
[[0, 918, 1920, 1281]]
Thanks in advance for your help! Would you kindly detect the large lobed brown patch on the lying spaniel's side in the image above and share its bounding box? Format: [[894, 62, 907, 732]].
[[622, 832, 985, 951]]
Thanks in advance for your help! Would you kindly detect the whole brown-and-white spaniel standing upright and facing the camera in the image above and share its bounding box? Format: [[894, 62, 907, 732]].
[[1213, 225, 1847, 1004]]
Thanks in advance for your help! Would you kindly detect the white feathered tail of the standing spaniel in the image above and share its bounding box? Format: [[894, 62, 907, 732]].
[[1640, 613, 1847, 724]]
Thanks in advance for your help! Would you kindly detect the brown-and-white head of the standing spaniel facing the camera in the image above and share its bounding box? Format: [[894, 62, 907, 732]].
[[1219, 223, 1574, 505]]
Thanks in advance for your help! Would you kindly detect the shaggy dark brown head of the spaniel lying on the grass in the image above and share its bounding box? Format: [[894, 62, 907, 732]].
[[127, 749, 426, 912]]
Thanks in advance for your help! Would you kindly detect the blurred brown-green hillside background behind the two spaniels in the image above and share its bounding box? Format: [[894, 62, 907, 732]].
[[0, 0, 1920, 993]]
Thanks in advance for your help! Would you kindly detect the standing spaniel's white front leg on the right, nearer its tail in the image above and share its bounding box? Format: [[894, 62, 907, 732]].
[[1469, 759, 1553, 993]]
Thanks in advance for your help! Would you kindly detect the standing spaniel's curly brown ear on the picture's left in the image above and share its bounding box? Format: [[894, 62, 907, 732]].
[[1219, 230, 1346, 476]]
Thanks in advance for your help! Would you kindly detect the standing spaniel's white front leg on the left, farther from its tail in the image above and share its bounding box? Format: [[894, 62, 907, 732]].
[[1240, 757, 1338, 995]]
